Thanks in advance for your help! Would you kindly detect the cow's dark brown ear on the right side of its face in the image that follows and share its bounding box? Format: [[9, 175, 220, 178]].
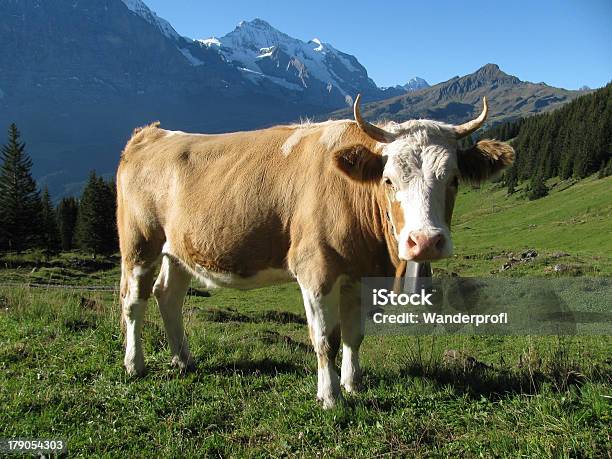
[[457, 140, 514, 183]]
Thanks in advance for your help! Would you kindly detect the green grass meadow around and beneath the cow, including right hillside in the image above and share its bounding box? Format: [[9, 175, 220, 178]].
[[0, 178, 612, 458]]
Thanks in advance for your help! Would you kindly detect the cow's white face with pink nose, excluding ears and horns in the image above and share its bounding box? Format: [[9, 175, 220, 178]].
[[382, 121, 459, 261]]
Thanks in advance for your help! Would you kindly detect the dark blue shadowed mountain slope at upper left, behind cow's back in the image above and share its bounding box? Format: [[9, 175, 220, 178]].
[[0, 0, 256, 196]]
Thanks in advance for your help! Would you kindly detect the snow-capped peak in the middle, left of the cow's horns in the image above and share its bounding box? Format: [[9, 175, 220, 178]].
[[197, 19, 394, 105]]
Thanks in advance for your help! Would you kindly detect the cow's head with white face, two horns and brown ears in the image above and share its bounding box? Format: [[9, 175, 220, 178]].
[[334, 96, 514, 261]]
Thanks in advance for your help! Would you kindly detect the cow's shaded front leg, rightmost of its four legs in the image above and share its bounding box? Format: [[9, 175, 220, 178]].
[[340, 283, 365, 392]]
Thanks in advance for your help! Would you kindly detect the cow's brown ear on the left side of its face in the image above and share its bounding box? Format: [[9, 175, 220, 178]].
[[333, 145, 384, 182]]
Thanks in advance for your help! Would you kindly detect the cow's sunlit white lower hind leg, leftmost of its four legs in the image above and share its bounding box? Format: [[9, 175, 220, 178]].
[[121, 262, 153, 375]]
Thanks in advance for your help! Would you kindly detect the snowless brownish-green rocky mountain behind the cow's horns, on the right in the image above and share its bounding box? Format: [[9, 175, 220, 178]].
[[332, 64, 584, 126]]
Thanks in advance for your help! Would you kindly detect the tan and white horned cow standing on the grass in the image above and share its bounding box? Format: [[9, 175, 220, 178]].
[[116, 96, 514, 408]]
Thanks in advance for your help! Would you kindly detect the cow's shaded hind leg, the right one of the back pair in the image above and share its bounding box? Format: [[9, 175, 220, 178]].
[[153, 255, 194, 371]]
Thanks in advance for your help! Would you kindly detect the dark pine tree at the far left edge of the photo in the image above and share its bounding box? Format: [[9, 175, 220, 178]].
[[0, 123, 41, 252]]
